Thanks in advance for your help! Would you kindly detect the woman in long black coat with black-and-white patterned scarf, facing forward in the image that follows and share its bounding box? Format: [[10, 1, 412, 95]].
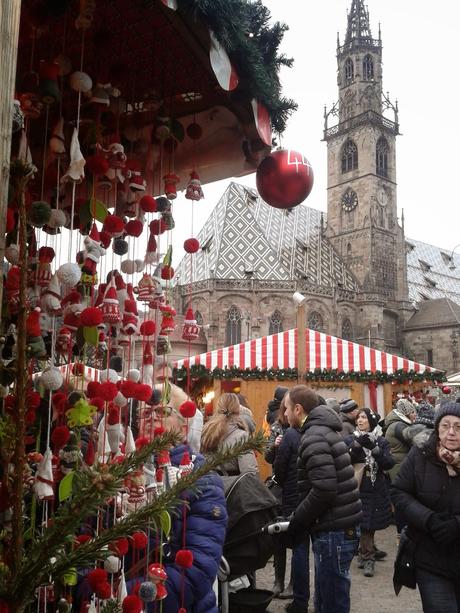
[[345, 409, 395, 577]]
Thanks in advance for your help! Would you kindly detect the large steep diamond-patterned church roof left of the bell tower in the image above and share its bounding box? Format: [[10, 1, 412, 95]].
[[178, 183, 358, 290]]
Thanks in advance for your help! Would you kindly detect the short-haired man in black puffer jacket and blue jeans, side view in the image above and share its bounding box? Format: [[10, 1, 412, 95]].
[[285, 385, 362, 613]]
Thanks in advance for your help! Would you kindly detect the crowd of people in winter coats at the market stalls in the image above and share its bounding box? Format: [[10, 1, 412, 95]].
[[76, 378, 460, 613]]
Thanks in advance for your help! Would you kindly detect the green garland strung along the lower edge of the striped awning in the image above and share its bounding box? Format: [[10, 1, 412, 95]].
[[174, 364, 446, 384]]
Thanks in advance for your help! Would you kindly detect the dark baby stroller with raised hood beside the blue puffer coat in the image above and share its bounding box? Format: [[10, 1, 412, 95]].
[[218, 473, 279, 613]]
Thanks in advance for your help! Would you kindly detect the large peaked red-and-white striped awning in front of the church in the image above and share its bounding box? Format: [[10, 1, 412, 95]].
[[176, 329, 436, 374]]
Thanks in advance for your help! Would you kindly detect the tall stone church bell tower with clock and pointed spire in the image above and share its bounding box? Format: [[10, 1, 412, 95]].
[[324, 0, 404, 300]]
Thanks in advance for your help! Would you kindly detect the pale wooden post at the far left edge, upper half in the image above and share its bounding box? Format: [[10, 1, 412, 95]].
[[0, 0, 21, 314]]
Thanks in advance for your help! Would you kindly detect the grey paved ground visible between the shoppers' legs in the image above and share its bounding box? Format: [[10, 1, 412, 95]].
[[257, 526, 422, 613]]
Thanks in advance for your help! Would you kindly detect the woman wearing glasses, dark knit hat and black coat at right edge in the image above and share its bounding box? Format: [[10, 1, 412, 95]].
[[392, 402, 460, 613]]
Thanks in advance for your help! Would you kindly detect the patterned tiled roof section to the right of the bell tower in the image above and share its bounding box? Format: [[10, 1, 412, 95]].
[[406, 238, 460, 304]]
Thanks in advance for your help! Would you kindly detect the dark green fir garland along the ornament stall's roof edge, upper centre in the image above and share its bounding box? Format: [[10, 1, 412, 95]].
[[178, 0, 297, 133]]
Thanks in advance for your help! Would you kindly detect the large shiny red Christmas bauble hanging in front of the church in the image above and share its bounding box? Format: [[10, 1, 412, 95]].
[[256, 149, 313, 209]]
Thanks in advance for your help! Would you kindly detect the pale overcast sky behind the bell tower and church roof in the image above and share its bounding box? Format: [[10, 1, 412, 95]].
[[173, 0, 460, 263]]
